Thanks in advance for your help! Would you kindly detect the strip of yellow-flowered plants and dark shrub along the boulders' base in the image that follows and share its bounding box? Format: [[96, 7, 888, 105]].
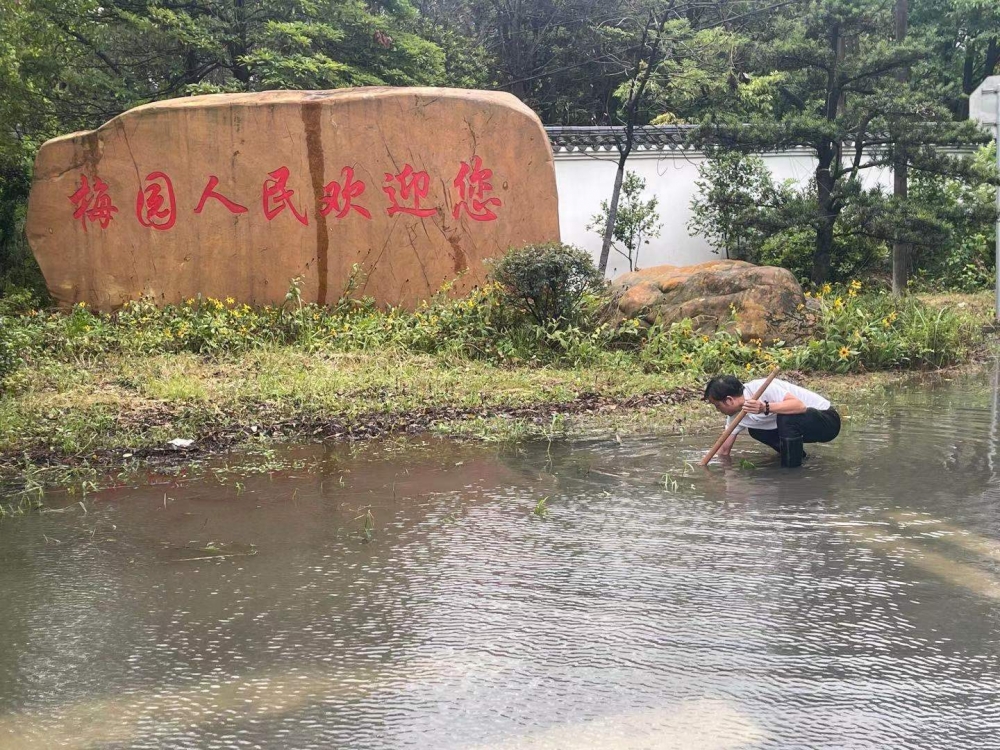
[[0, 268, 985, 394]]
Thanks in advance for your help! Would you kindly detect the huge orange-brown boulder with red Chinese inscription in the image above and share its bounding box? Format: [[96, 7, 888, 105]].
[[27, 88, 559, 310]]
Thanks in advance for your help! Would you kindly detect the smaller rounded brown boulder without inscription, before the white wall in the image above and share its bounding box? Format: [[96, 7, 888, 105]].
[[611, 260, 814, 343]]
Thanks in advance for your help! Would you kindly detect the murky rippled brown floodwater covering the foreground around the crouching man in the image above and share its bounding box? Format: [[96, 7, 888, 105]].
[[0, 376, 1000, 750]]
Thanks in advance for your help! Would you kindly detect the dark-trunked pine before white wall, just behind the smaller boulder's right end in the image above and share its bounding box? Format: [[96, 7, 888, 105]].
[[698, 0, 983, 284]]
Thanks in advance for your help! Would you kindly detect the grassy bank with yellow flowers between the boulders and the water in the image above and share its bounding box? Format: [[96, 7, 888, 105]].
[[0, 287, 992, 496]]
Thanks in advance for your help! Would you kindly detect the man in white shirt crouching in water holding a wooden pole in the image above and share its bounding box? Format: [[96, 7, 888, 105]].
[[705, 375, 840, 466]]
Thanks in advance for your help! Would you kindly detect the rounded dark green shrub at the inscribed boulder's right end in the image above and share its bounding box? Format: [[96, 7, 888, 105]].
[[490, 242, 604, 327]]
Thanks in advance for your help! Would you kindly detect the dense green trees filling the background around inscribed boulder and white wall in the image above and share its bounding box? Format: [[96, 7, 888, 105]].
[[0, 0, 1000, 293]]
